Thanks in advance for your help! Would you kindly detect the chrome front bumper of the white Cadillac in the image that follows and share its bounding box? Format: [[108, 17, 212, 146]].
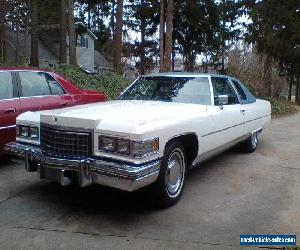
[[4, 142, 160, 191]]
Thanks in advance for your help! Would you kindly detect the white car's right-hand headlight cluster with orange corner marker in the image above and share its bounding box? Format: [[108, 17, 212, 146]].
[[99, 136, 159, 158]]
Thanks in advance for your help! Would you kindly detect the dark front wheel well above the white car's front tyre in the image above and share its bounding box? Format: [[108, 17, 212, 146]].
[[167, 134, 199, 166]]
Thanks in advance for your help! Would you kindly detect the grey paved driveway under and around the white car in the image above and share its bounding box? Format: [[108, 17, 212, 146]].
[[0, 113, 300, 249]]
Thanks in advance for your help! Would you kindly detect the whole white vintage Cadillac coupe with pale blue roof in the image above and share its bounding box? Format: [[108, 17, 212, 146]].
[[6, 73, 271, 206]]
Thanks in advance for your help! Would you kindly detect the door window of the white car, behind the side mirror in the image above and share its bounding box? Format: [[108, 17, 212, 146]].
[[211, 77, 239, 105]]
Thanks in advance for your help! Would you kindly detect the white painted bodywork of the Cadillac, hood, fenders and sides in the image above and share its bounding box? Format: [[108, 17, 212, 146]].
[[17, 95, 271, 164]]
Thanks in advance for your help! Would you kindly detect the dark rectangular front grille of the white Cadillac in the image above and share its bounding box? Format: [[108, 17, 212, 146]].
[[40, 124, 91, 157]]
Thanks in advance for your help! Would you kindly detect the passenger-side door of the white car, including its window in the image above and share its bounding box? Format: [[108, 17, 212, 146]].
[[205, 77, 244, 148]]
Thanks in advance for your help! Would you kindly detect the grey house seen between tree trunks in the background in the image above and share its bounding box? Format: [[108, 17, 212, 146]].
[[2, 22, 113, 72]]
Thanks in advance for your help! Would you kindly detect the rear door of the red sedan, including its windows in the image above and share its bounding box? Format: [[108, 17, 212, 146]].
[[18, 71, 73, 112]]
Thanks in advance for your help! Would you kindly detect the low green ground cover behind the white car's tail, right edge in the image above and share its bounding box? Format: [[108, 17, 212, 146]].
[[268, 99, 299, 117]]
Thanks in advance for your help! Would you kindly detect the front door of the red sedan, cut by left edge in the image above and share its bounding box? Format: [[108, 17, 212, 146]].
[[0, 71, 21, 153]]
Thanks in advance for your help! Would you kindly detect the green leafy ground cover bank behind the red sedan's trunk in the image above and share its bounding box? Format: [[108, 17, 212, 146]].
[[51, 65, 131, 100]]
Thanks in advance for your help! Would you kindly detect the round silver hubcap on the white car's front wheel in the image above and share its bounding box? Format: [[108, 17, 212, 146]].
[[166, 149, 185, 197]]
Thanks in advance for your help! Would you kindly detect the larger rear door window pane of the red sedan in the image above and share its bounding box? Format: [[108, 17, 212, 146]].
[[19, 71, 51, 97]]
